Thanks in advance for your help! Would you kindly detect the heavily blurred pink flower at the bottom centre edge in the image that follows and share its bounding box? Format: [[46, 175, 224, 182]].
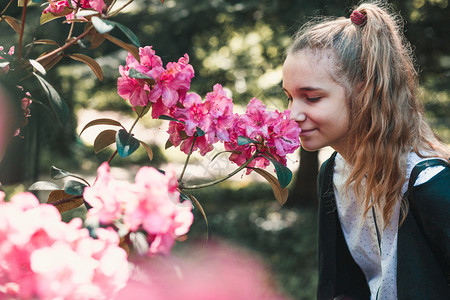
[[114, 244, 287, 300]]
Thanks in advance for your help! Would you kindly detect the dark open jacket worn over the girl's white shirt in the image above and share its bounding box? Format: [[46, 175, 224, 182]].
[[317, 153, 450, 300]]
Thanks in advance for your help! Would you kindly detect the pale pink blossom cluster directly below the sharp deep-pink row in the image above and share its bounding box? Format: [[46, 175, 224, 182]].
[[83, 163, 194, 254]]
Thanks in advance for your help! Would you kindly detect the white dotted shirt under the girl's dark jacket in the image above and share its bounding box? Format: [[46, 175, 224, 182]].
[[333, 153, 444, 300]]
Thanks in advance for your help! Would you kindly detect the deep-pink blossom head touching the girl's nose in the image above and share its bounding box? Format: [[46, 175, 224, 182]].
[[225, 98, 300, 174]]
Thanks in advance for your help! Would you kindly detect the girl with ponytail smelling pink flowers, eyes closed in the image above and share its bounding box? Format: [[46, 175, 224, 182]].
[[283, 3, 450, 300]]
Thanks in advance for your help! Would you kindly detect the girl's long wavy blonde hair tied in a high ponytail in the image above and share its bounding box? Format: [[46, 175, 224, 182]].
[[288, 1, 450, 224]]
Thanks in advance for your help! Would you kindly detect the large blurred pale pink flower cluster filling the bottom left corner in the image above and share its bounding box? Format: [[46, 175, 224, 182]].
[[0, 192, 129, 299]]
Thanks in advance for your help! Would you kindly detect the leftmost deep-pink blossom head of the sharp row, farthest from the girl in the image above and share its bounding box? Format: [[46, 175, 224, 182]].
[[117, 46, 194, 118]]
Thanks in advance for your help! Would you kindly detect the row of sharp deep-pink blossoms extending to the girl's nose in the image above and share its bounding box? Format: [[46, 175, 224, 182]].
[[117, 46, 300, 172]]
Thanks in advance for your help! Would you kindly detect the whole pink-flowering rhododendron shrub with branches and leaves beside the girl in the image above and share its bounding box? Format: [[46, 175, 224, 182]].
[[0, 0, 300, 299]]
